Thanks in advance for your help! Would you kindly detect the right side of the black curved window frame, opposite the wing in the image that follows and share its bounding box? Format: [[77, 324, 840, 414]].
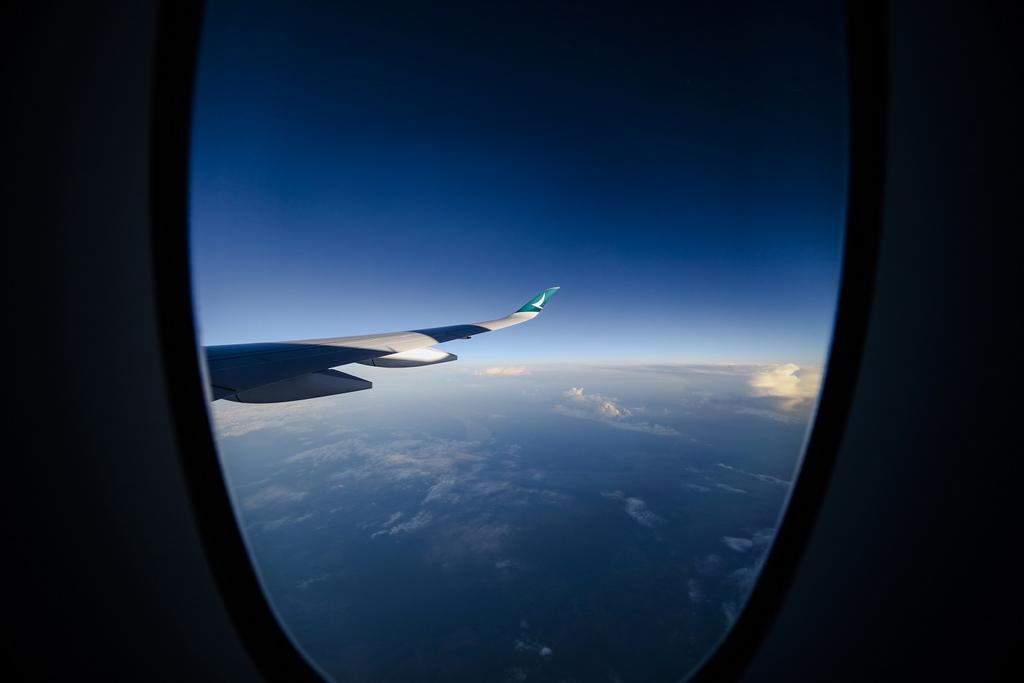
[[689, 0, 888, 683]]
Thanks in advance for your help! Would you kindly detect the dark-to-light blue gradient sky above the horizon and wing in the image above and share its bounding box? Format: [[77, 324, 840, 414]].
[[191, 0, 847, 364]]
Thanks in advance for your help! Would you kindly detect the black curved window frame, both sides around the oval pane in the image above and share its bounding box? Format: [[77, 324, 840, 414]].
[[150, 0, 887, 683]]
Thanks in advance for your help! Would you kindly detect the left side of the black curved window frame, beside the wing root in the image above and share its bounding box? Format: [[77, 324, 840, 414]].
[[150, 0, 324, 682]]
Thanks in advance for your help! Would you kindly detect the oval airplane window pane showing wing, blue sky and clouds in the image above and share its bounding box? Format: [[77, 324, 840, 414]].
[[190, 0, 847, 681]]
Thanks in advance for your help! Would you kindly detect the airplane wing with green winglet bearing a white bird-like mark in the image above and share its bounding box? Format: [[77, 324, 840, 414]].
[[204, 287, 558, 403]]
